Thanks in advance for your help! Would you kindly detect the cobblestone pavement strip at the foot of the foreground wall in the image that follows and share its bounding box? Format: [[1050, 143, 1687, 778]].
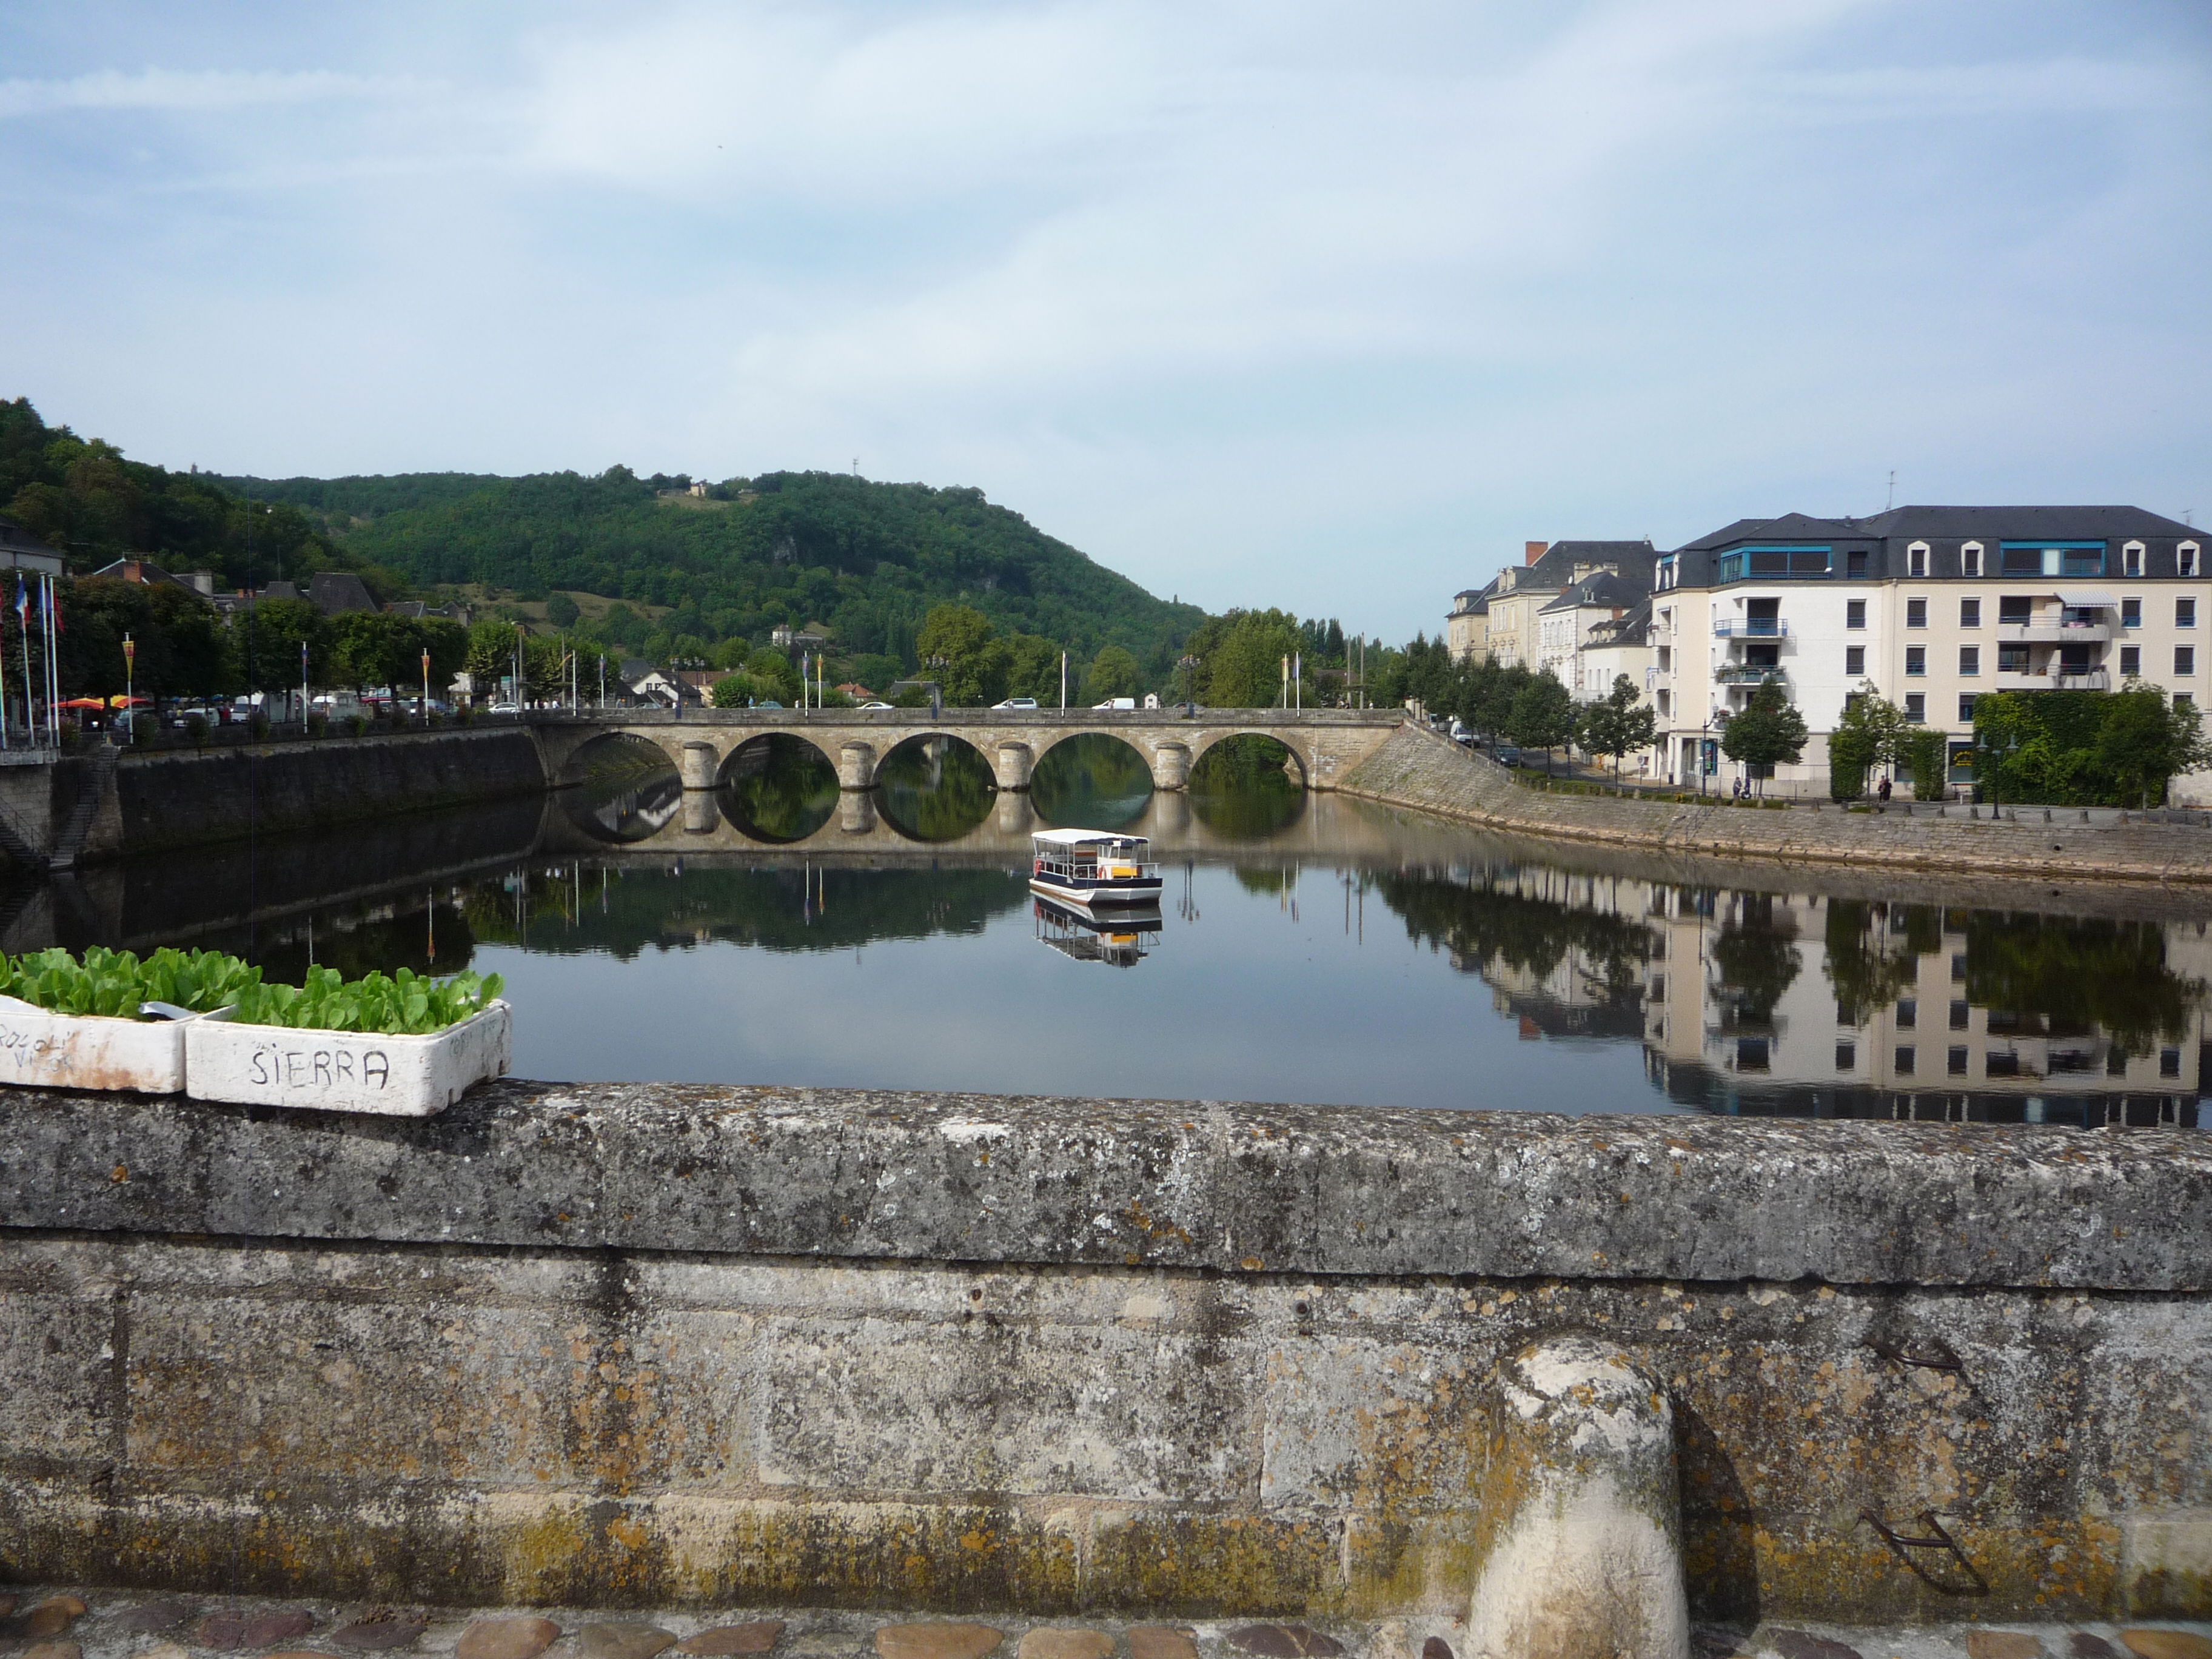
[[0, 1588, 2212, 1659]]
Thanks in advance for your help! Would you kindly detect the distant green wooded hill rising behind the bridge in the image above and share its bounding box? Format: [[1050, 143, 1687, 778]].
[[221, 467, 1205, 672]]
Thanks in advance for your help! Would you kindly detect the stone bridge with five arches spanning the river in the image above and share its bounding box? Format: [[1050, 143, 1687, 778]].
[[526, 708, 1404, 789]]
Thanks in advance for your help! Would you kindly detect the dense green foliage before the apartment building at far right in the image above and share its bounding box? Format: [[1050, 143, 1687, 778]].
[[1973, 683, 2212, 808]]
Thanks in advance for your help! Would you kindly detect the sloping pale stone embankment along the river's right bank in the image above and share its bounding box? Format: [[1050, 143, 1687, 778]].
[[1338, 723, 2212, 885]]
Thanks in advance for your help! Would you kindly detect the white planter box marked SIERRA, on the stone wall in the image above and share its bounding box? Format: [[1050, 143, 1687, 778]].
[[184, 1002, 513, 1117]]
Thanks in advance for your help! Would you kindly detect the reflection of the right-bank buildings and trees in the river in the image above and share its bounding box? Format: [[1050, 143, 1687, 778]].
[[1376, 865, 2212, 1128]]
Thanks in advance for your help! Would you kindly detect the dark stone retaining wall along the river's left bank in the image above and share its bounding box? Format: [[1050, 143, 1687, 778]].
[[100, 726, 546, 856]]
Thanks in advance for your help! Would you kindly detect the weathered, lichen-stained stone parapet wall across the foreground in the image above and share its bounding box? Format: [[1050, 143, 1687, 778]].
[[0, 1084, 2212, 1619]]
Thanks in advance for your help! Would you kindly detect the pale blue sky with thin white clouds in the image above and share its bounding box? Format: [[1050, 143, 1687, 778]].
[[0, 0, 2212, 639]]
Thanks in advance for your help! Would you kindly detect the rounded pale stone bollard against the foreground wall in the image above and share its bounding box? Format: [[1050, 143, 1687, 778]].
[[1467, 1336, 1690, 1659]]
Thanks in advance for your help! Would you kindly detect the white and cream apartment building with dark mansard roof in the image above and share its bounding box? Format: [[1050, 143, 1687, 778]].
[[1650, 506, 2212, 799]]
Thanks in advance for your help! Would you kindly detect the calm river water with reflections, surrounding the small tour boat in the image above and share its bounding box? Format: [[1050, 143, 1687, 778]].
[[47, 743, 2212, 1126]]
